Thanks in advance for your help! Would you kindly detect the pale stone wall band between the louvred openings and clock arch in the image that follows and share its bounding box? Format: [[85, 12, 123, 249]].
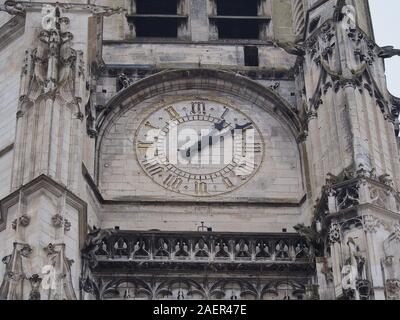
[[103, 42, 295, 70]]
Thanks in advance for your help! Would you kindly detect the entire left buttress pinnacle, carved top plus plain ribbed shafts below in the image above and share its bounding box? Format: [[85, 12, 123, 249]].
[[12, 5, 88, 190]]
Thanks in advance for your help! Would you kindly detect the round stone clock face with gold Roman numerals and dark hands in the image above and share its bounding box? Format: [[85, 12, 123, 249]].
[[135, 100, 264, 197]]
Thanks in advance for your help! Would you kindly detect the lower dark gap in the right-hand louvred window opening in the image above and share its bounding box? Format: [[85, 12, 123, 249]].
[[217, 19, 260, 39]]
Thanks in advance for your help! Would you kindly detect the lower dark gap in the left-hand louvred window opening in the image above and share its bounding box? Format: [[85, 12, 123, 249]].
[[135, 18, 179, 38]]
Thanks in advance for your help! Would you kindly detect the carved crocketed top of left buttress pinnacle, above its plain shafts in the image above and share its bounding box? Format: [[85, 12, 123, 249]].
[[22, 5, 86, 109]]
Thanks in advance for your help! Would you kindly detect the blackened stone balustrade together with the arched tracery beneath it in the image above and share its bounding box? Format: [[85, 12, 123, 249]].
[[80, 230, 314, 299]]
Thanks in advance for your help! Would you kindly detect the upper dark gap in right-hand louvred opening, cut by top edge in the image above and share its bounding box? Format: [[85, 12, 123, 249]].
[[216, 0, 259, 16]]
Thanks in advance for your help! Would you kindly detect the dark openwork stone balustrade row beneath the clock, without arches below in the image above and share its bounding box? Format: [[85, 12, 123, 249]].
[[90, 231, 312, 268]]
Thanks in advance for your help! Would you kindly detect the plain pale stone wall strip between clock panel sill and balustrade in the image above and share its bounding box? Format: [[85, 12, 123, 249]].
[[101, 203, 300, 233]]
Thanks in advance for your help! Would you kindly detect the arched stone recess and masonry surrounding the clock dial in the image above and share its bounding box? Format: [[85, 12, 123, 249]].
[[96, 69, 304, 203]]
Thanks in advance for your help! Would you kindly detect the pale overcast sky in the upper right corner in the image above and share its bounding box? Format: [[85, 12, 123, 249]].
[[369, 0, 400, 97]]
